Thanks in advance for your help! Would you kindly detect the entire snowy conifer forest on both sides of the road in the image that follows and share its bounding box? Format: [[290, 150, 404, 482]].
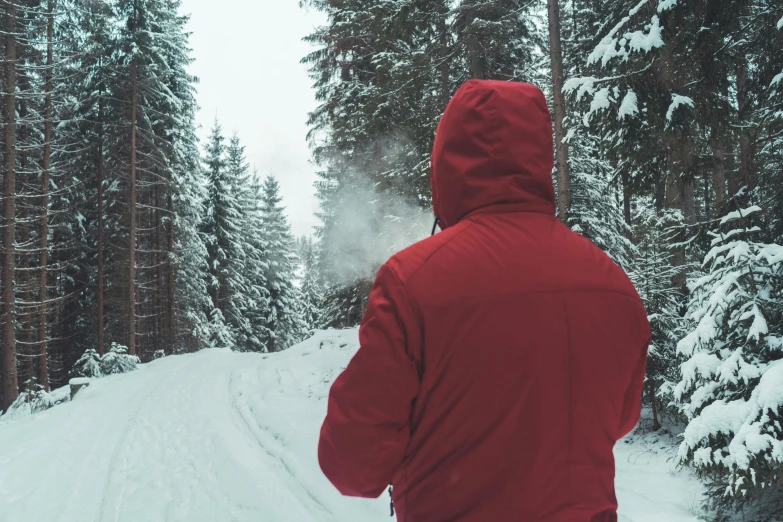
[[0, 0, 783, 520]]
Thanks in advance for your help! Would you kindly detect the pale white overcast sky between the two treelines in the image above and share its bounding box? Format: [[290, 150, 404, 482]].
[[182, 0, 324, 235]]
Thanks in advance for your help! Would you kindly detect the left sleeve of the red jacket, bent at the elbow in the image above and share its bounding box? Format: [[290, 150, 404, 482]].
[[318, 266, 421, 498]]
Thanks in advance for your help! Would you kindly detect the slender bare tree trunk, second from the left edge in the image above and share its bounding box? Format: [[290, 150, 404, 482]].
[[38, 0, 54, 391]]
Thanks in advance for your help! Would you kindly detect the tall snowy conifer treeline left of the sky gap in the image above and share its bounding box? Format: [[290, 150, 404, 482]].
[[0, 0, 306, 411]]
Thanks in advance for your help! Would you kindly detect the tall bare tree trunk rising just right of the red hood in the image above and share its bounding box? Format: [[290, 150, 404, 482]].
[[547, 0, 571, 224]]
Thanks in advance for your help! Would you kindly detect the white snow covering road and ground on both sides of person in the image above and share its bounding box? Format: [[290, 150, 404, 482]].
[[0, 330, 700, 522]]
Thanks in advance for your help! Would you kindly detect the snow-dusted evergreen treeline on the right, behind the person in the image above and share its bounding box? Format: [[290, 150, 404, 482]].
[[304, 0, 783, 519]]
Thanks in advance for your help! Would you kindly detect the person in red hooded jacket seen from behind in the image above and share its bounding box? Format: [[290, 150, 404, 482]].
[[318, 80, 650, 522]]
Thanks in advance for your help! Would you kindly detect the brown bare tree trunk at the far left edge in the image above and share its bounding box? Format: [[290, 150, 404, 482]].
[[0, 2, 19, 411]]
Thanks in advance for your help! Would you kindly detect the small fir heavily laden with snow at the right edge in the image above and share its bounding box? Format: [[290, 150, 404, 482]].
[[673, 206, 783, 505]]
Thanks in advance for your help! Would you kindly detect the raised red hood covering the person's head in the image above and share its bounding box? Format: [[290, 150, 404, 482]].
[[430, 80, 555, 228]]
